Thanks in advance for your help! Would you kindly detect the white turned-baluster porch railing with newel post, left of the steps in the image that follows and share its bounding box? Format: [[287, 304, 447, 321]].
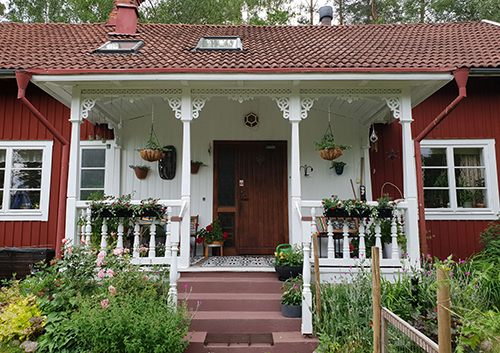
[[72, 200, 189, 302]]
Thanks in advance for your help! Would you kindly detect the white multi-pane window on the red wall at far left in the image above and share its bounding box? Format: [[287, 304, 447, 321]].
[[0, 141, 52, 220]]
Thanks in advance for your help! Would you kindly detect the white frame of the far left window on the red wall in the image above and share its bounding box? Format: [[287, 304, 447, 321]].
[[0, 141, 54, 222]]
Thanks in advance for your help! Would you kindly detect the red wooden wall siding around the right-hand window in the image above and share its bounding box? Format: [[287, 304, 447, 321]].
[[370, 77, 500, 258]]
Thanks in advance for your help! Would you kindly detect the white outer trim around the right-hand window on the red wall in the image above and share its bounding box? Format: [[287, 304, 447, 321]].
[[420, 139, 500, 220]]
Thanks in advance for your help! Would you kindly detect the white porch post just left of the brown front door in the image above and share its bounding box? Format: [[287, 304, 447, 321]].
[[179, 88, 193, 267]]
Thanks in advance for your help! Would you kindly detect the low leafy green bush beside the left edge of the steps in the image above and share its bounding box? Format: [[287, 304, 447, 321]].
[[69, 289, 189, 353]]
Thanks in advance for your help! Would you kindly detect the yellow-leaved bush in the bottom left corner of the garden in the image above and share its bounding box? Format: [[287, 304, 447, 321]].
[[0, 281, 44, 342]]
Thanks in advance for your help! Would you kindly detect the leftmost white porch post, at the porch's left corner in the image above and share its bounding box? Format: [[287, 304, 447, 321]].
[[65, 87, 82, 244]]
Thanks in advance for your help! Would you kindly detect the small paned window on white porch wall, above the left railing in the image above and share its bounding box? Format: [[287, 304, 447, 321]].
[[80, 147, 106, 200]]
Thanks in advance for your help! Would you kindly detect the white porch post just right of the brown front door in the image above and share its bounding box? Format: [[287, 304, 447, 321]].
[[289, 87, 302, 244]]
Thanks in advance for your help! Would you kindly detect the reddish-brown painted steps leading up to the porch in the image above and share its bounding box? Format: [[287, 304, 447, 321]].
[[181, 272, 318, 353]]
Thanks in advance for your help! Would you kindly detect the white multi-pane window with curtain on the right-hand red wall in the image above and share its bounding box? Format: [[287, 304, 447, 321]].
[[421, 140, 498, 214]]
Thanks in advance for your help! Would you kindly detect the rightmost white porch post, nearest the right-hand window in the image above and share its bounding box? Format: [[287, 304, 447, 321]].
[[399, 88, 425, 266]]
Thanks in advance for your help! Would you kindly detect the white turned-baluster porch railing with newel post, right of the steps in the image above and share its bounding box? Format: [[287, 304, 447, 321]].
[[294, 201, 409, 334]]
